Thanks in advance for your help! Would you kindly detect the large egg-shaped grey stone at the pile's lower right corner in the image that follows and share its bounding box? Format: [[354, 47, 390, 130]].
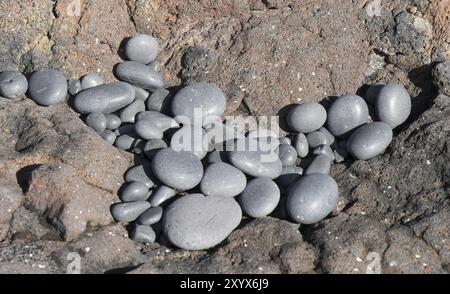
[[286, 174, 339, 224]]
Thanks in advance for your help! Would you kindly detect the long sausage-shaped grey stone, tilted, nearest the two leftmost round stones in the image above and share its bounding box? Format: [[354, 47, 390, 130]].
[[73, 82, 135, 114]]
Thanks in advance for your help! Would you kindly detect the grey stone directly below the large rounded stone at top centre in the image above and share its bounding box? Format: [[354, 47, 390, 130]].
[[170, 125, 209, 159]]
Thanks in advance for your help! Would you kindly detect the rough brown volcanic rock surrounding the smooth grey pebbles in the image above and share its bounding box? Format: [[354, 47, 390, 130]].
[[0, 0, 450, 273]]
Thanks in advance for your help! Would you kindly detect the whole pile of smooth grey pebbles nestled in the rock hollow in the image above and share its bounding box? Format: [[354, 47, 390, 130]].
[[0, 35, 411, 250]]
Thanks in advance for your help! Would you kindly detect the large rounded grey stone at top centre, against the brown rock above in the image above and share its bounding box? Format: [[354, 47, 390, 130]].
[[172, 83, 226, 124]]
